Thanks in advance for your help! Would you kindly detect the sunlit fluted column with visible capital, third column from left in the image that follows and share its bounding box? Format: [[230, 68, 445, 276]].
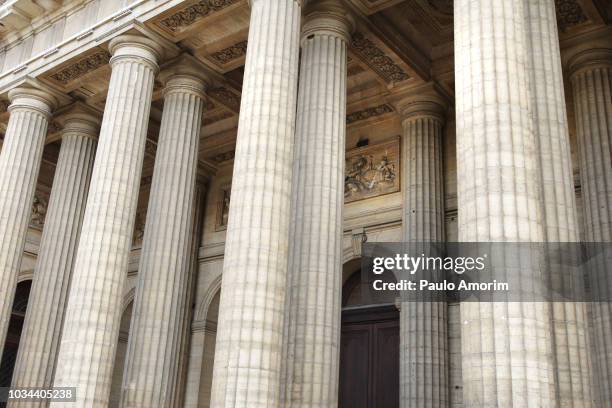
[[51, 35, 160, 408]]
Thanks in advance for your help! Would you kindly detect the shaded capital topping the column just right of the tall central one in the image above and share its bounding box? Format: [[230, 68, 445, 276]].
[[302, 0, 355, 43]]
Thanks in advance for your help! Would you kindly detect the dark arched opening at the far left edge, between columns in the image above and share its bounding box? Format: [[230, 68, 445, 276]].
[[0, 280, 32, 407]]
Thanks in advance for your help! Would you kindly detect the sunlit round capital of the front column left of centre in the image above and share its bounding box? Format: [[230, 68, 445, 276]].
[[108, 34, 163, 71]]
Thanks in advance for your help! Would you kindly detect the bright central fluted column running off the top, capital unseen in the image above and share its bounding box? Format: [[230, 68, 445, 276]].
[[211, 0, 301, 408]]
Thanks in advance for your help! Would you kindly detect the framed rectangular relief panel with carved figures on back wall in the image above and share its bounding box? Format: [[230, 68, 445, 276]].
[[344, 138, 400, 203]]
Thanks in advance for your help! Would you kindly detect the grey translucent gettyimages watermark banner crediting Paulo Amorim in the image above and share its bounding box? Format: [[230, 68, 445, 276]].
[[361, 242, 612, 302]]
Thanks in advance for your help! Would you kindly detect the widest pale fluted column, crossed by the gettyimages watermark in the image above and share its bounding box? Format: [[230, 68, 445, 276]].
[[454, 0, 555, 408]]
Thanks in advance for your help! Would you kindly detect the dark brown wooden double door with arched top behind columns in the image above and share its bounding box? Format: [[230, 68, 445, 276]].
[[339, 262, 399, 408]]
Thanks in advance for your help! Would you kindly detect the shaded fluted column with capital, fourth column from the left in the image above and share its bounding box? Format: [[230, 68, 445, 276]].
[[121, 74, 204, 408]]
